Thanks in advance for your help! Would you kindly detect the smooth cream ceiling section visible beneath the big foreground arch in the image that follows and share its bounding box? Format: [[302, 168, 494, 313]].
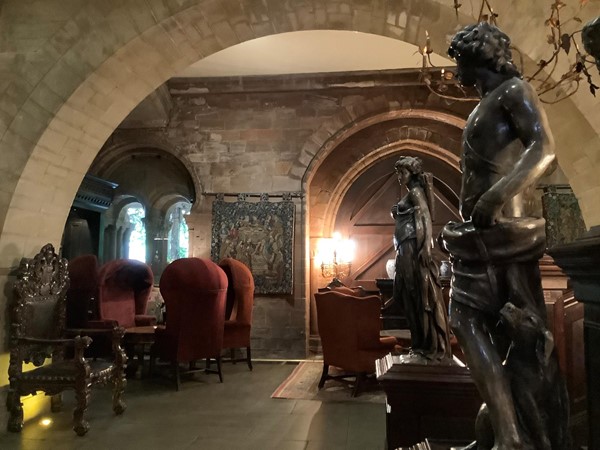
[[177, 30, 455, 77]]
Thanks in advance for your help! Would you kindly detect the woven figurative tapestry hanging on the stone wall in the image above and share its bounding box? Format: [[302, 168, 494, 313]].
[[211, 194, 294, 294]]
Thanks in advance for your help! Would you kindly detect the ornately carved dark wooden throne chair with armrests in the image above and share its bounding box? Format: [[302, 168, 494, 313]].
[[6, 244, 126, 436]]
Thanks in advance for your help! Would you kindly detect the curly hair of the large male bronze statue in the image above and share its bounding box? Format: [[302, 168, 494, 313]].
[[448, 22, 521, 78]]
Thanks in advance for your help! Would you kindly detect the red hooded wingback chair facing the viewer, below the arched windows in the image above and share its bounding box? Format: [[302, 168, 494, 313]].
[[98, 259, 156, 328]]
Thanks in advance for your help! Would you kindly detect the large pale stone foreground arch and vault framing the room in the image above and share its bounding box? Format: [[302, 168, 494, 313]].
[[0, 0, 600, 268]]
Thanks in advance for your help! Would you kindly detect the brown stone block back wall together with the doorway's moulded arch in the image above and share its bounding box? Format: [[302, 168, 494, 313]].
[[92, 71, 568, 358]]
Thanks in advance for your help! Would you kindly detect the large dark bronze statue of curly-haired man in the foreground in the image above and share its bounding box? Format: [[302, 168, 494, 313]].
[[442, 22, 558, 450]]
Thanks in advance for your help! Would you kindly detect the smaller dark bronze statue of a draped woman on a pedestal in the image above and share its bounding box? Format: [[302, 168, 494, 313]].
[[392, 156, 452, 361]]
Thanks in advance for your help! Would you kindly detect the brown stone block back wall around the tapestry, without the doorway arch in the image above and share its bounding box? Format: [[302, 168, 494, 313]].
[[103, 70, 460, 358]]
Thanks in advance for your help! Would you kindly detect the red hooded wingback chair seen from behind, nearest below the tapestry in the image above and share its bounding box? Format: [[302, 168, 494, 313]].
[[151, 258, 227, 390]]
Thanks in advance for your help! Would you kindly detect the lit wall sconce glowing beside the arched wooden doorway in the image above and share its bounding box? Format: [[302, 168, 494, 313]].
[[315, 232, 354, 279]]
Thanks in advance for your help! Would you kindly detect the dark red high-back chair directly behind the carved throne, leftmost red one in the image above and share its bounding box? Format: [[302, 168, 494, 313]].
[[67, 255, 99, 328]]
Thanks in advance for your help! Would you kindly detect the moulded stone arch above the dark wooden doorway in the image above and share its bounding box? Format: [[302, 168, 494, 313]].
[[302, 101, 465, 237]]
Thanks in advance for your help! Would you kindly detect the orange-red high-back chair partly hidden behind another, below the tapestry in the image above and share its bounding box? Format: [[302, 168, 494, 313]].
[[219, 258, 254, 370]]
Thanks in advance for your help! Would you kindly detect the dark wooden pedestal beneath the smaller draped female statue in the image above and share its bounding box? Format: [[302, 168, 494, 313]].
[[377, 354, 482, 450]]
